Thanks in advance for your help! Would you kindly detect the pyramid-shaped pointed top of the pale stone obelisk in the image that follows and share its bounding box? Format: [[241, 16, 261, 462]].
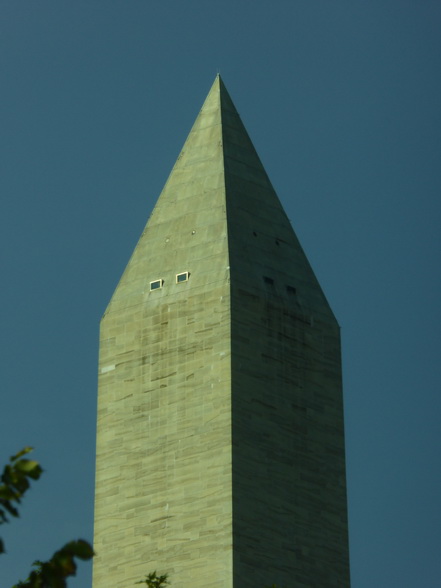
[[108, 75, 330, 322]]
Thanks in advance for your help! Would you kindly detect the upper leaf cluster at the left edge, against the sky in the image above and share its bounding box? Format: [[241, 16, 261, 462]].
[[0, 447, 43, 553]]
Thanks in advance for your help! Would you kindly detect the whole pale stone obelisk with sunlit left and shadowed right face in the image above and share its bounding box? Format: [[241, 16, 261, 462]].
[[93, 76, 349, 588]]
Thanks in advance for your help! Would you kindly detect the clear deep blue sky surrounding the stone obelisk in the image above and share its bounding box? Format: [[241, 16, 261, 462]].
[[0, 0, 441, 588]]
